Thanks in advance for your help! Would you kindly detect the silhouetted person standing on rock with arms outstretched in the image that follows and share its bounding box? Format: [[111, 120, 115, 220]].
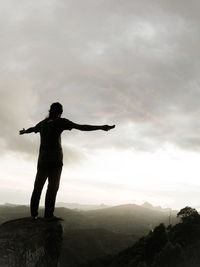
[[19, 102, 115, 220]]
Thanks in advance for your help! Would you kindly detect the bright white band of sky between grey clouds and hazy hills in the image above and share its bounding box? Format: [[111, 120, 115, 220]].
[[0, 146, 200, 208]]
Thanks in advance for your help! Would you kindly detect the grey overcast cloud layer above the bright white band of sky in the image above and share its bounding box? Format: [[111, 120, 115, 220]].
[[0, 0, 200, 161]]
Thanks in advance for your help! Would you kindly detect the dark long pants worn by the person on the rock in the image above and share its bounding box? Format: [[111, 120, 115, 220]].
[[31, 162, 62, 218]]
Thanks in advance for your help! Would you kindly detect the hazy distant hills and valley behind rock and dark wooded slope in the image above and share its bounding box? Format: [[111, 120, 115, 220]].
[[0, 203, 177, 267]]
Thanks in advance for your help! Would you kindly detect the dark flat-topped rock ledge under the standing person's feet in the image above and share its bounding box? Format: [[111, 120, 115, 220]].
[[0, 218, 63, 267]]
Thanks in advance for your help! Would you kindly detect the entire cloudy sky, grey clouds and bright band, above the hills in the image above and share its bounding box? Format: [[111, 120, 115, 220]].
[[0, 0, 200, 209]]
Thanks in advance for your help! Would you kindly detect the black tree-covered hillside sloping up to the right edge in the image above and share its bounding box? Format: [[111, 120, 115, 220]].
[[84, 206, 200, 267]]
